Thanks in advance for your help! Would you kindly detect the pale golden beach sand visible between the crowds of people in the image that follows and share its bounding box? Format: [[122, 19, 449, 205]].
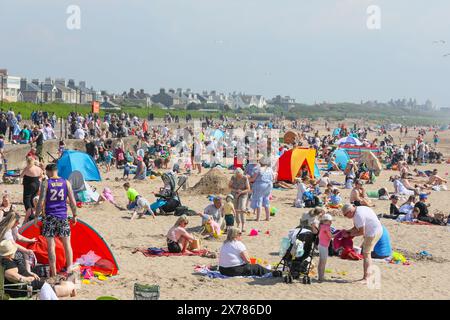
[[0, 122, 450, 300]]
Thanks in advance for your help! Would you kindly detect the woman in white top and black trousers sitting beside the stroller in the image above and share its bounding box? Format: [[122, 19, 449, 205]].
[[219, 227, 272, 277]]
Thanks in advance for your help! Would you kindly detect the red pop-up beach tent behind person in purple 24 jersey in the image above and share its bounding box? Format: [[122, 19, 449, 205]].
[[19, 220, 119, 275]]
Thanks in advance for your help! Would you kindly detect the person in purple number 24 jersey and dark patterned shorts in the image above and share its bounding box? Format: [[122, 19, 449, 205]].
[[34, 163, 77, 276]]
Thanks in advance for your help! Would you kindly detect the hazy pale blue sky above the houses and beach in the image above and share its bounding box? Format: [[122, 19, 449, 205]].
[[0, 0, 450, 106]]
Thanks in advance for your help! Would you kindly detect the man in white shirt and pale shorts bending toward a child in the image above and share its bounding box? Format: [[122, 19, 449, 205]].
[[342, 204, 383, 283]]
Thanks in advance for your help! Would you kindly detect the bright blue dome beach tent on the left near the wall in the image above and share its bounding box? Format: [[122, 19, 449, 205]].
[[58, 150, 102, 181]]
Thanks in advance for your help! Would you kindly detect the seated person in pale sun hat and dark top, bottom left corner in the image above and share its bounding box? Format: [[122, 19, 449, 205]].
[[0, 240, 76, 298]]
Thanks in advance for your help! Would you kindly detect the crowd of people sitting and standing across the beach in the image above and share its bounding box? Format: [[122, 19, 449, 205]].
[[0, 110, 448, 296]]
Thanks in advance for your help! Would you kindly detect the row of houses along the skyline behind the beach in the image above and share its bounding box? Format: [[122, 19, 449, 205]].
[[0, 69, 295, 110]]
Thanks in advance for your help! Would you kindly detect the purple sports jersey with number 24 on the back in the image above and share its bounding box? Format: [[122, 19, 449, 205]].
[[45, 178, 68, 219]]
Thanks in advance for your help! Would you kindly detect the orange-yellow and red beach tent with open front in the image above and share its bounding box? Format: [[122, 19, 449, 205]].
[[278, 148, 316, 182]]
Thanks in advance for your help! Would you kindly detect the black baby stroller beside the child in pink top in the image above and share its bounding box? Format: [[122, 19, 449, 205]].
[[276, 227, 317, 284]]
